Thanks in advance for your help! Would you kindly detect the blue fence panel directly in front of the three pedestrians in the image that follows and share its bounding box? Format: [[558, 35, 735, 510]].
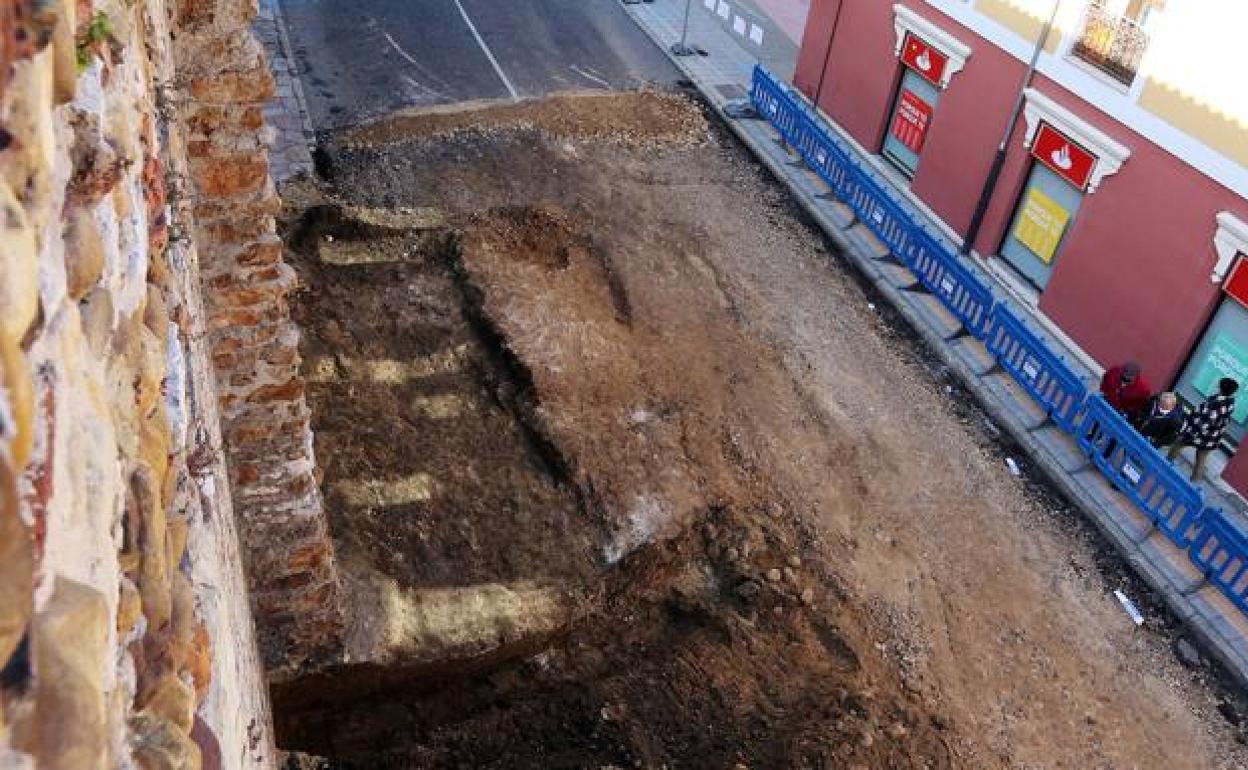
[[1077, 393, 1204, 549]]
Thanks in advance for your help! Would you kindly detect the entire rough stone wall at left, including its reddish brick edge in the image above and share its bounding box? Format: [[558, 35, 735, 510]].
[[0, 0, 342, 770]]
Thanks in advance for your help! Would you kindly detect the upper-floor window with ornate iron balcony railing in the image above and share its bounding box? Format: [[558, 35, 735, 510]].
[[1071, 0, 1166, 86]]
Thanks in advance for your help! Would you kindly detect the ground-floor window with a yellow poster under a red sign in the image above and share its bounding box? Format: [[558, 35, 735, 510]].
[[1001, 161, 1083, 290]]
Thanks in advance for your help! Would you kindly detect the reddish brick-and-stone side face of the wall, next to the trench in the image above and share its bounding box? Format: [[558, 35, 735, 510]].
[[176, 0, 343, 676]]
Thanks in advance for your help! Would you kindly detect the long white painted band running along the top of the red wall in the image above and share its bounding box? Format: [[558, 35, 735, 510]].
[[925, 0, 1248, 204]]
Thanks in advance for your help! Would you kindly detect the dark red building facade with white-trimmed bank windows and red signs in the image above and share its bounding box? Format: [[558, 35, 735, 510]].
[[794, 0, 1248, 492]]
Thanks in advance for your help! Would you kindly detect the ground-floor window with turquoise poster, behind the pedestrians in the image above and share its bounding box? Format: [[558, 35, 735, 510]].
[[1176, 287, 1248, 444]]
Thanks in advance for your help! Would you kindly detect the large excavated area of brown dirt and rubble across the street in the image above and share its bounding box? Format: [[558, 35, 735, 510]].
[[275, 95, 1248, 769]]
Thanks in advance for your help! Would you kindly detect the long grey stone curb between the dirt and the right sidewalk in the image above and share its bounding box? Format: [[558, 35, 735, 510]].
[[625, 3, 1248, 690]]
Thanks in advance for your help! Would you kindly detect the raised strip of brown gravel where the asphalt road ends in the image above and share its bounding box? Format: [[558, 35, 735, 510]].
[[342, 91, 706, 147]]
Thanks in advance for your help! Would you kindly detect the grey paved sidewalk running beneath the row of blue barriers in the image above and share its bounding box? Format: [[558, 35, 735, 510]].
[[625, 0, 1248, 686]]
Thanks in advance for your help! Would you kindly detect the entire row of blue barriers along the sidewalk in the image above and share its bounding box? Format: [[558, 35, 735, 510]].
[[750, 66, 1248, 626]]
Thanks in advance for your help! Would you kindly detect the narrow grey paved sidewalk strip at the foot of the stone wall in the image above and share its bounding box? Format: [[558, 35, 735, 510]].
[[252, 0, 312, 183]]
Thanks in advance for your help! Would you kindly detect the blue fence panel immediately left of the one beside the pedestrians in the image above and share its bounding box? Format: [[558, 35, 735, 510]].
[[986, 302, 1087, 433]]
